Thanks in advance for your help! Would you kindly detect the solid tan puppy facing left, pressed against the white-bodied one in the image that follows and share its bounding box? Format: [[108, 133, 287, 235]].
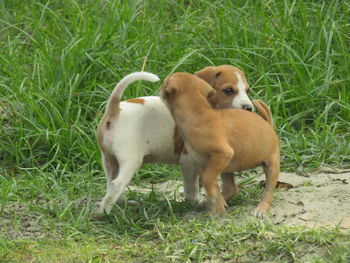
[[160, 73, 280, 217]]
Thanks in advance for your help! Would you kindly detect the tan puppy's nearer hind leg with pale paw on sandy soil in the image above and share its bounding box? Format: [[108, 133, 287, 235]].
[[252, 153, 280, 218]]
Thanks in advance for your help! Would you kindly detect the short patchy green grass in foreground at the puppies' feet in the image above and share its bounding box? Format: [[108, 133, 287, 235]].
[[0, 169, 350, 262]]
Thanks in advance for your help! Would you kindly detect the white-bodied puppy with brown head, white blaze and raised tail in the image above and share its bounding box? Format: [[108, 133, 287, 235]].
[[95, 66, 253, 215]]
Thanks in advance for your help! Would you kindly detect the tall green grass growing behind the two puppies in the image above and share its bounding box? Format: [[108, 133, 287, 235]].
[[0, 0, 350, 171]]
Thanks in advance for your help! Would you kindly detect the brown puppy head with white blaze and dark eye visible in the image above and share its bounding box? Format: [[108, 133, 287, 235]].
[[195, 65, 253, 111]]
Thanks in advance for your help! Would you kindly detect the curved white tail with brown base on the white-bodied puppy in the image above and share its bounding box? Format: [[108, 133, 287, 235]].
[[106, 72, 159, 116]]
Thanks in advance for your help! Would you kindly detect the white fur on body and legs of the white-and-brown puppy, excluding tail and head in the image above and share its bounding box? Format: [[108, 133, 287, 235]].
[[96, 96, 202, 213]]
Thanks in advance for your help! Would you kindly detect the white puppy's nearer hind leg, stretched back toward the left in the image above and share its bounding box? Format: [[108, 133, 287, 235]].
[[100, 156, 143, 214]]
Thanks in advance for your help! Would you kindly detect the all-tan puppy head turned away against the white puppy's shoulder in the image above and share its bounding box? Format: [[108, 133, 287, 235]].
[[159, 72, 216, 109]]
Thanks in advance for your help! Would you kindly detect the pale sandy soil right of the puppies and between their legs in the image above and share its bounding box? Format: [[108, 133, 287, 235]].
[[137, 168, 350, 230]]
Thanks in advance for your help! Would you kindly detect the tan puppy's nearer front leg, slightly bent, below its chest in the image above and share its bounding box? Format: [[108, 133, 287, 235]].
[[200, 148, 233, 215]]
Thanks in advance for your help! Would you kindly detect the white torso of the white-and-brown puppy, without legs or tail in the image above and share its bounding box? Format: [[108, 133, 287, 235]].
[[104, 96, 179, 163]]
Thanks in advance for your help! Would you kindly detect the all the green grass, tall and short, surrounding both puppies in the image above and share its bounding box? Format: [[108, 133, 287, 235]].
[[0, 0, 350, 262]]
